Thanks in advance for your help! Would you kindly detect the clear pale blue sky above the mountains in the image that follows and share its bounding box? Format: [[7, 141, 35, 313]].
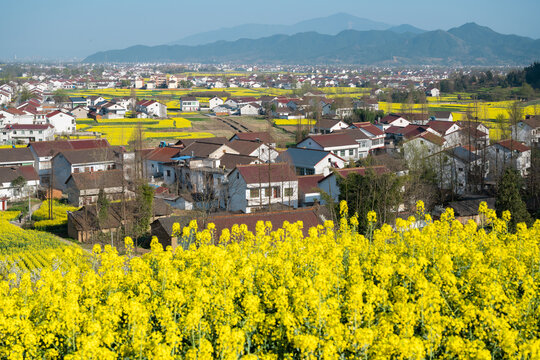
[[0, 0, 540, 60]]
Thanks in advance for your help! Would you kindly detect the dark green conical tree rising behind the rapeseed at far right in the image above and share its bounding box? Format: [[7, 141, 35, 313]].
[[495, 168, 531, 231]]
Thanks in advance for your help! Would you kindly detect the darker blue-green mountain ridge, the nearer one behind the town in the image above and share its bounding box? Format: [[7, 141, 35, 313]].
[[84, 24, 540, 66]]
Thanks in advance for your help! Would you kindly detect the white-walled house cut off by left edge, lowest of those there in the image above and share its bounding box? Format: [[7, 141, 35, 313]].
[[0, 166, 39, 201]]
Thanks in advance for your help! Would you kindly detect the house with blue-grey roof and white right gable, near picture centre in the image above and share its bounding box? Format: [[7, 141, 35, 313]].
[[276, 148, 347, 176]]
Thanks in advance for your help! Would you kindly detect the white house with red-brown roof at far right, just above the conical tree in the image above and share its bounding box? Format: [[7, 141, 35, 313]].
[[487, 139, 531, 178]]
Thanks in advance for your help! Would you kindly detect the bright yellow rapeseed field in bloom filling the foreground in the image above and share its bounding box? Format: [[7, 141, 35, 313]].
[[0, 205, 540, 360]]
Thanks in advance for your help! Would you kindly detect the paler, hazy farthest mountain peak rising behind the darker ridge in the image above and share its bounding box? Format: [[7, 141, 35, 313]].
[[168, 13, 392, 46]]
